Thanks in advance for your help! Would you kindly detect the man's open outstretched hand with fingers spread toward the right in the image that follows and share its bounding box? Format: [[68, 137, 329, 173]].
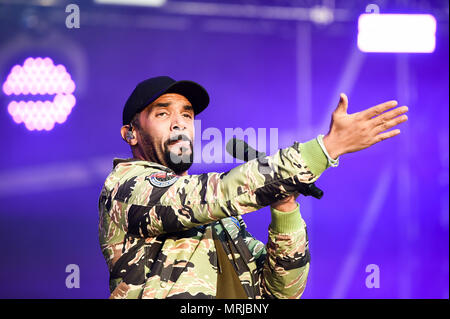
[[323, 93, 408, 159]]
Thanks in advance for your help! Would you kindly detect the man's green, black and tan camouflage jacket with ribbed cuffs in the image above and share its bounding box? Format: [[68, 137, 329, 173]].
[[99, 139, 328, 299]]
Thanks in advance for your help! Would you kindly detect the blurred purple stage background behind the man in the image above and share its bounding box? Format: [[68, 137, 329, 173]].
[[0, 1, 449, 298]]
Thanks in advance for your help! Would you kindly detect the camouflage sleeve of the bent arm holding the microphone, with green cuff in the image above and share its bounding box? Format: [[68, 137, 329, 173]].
[[260, 204, 310, 299]]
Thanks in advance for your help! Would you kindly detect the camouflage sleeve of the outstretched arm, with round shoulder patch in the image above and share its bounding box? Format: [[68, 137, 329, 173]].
[[120, 139, 328, 237]]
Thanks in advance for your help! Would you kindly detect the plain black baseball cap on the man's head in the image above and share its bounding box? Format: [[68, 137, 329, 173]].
[[122, 76, 209, 125]]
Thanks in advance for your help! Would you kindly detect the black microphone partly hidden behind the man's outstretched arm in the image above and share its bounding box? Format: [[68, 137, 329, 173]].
[[225, 137, 323, 199]]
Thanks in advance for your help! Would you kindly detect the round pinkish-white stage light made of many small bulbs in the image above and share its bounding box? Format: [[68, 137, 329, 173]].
[[3, 57, 76, 131]]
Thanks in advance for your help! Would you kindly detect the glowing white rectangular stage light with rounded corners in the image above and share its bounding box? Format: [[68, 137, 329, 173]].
[[358, 13, 436, 53]]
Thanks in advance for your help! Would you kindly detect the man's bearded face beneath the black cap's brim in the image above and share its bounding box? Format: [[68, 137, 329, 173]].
[[137, 93, 194, 174]]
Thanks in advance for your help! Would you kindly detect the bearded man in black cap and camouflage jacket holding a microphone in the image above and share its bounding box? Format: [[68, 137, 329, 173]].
[[99, 76, 408, 298]]
